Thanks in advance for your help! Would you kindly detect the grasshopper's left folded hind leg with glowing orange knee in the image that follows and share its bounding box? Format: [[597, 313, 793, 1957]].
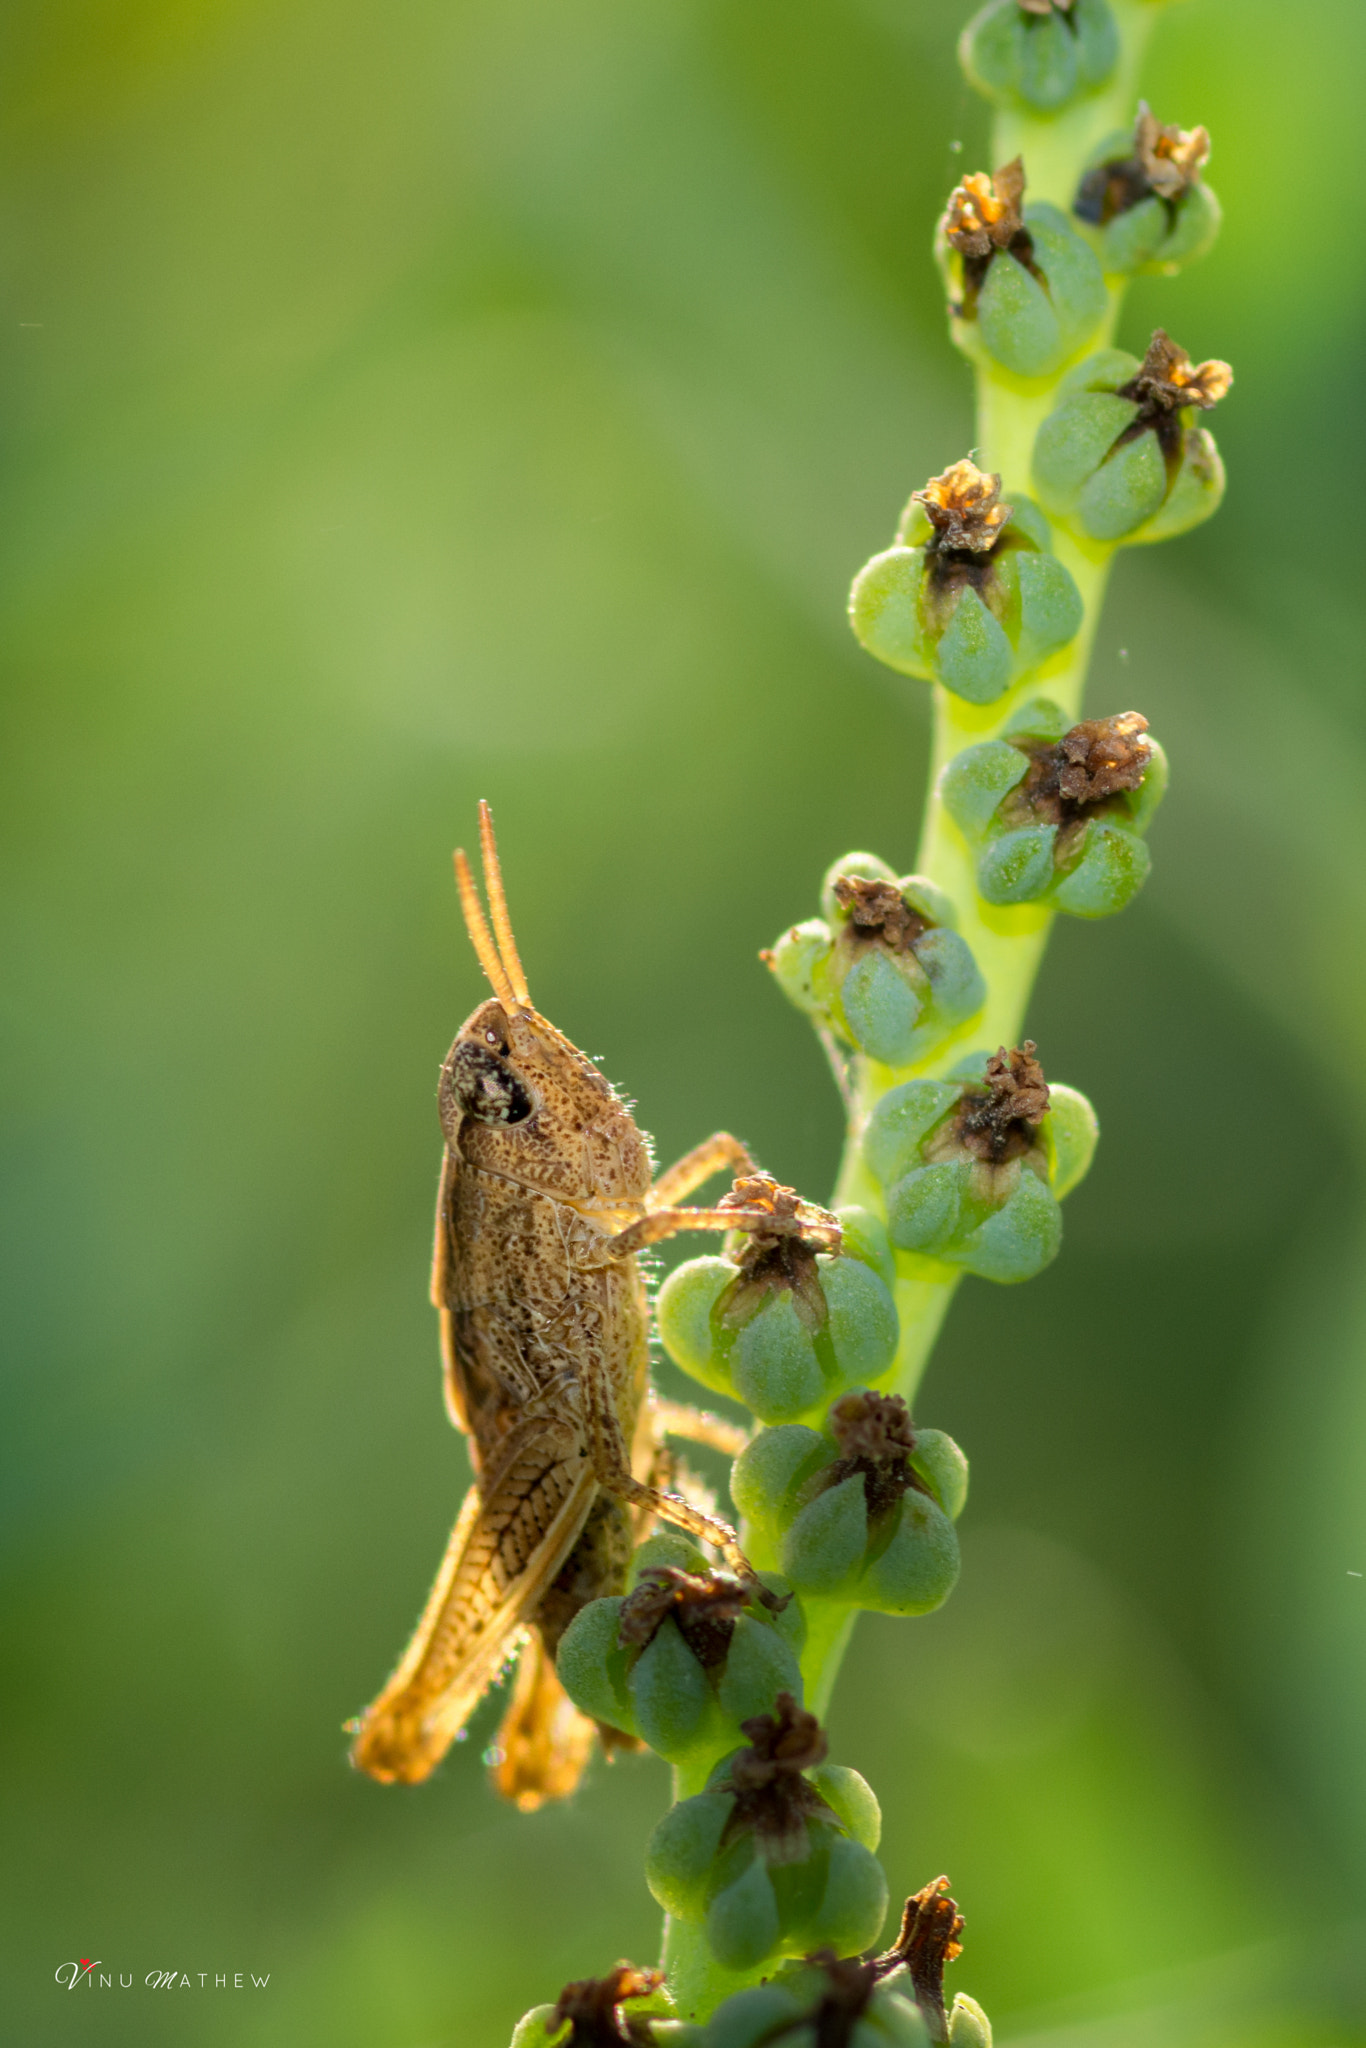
[[350, 1415, 598, 1784]]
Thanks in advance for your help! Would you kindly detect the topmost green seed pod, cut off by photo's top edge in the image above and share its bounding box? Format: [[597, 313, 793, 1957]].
[[958, 0, 1120, 115]]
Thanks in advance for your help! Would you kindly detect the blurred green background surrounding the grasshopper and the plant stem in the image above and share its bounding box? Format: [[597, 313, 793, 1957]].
[[0, 0, 1366, 2048]]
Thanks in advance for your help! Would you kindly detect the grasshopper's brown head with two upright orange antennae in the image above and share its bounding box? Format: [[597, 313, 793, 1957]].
[[436, 803, 651, 1206]]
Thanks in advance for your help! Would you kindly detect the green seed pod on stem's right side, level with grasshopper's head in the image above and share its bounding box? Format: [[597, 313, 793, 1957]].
[[864, 1038, 1096, 1282]]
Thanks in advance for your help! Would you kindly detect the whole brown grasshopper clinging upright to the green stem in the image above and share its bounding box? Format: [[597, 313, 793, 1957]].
[[352, 803, 838, 1806]]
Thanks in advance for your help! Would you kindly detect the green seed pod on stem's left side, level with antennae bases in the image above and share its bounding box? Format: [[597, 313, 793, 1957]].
[[762, 854, 987, 1067]]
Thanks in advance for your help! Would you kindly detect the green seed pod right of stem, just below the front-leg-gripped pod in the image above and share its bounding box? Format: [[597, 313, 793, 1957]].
[[731, 1393, 967, 1614]]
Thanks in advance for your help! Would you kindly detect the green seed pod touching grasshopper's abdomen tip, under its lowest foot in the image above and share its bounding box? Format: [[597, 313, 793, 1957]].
[[555, 1534, 805, 1763]]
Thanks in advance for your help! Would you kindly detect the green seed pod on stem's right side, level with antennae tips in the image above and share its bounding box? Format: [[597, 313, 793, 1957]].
[[940, 698, 1167, 918]]
